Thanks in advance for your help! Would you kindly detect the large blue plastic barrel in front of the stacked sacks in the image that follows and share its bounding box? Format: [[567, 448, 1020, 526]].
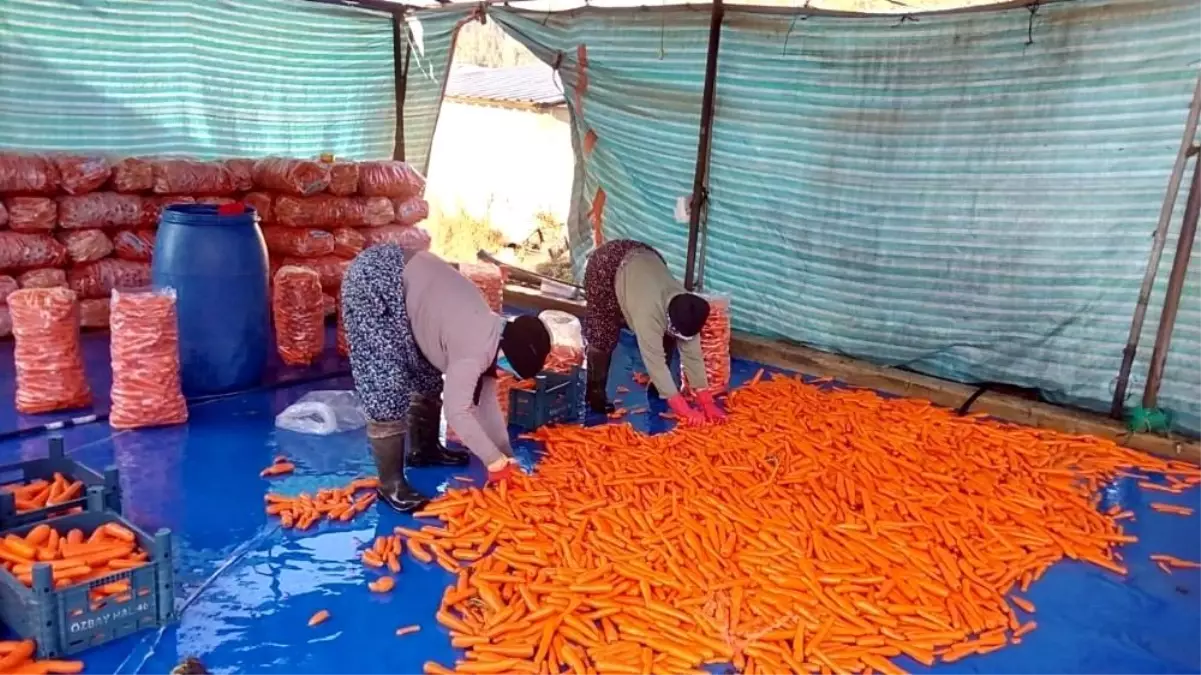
[[151, 204, 270, 396]]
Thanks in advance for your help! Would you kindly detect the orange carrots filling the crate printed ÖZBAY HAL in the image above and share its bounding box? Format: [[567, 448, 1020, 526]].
[[0, 522, 149, 595]]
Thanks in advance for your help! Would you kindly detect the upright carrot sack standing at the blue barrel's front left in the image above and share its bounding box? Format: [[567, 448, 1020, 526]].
[[108, 288, 187, 429]]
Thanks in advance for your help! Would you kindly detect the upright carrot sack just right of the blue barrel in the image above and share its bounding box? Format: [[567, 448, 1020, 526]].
[[271, 265, 325, 365]]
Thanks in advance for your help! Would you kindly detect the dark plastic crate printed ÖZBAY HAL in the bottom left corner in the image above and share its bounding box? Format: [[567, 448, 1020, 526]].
[[0, 490, 175, 658]]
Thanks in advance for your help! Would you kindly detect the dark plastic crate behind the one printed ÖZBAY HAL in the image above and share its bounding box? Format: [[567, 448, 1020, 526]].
[[0, 436, 121, 530]]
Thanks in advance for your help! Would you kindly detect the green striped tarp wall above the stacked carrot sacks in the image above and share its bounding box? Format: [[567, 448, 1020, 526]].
[[0, 0, 396, 159]]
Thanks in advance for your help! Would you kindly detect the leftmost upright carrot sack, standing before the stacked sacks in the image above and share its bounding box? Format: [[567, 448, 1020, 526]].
[[8, 288, 91, 414]]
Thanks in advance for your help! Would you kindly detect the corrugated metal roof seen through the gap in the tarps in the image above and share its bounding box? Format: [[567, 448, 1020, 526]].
[[447, 64, 563, 108]]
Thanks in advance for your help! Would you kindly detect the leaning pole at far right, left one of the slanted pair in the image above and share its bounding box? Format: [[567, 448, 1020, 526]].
[[1110, 69, 1201, 419]]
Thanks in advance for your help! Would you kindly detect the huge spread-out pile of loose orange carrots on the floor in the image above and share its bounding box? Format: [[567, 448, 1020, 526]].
[[396, 377, 1201, 675]]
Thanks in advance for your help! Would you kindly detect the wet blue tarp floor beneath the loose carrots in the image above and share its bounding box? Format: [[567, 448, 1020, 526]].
[[0, 331, 1201, 675]]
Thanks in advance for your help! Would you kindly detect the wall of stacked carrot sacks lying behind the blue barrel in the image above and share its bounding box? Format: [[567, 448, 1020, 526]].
[[0, 153, 430, 335]]
